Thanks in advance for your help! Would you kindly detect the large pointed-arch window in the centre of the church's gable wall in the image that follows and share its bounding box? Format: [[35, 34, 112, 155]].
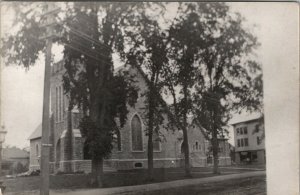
[[131, 115, 143, 151]]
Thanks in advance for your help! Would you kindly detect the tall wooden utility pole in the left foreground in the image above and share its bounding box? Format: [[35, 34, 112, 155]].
[[40, 3, 59, 195]]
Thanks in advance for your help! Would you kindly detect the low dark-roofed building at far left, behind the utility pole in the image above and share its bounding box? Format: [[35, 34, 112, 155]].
[[2, 147, 29, 175]]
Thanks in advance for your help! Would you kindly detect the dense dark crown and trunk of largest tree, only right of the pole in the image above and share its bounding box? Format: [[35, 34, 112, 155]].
[[60, 3, 142, 186]]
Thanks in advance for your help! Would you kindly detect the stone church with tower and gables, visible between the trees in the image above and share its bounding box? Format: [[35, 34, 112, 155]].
[[29, 61, 231, 173]]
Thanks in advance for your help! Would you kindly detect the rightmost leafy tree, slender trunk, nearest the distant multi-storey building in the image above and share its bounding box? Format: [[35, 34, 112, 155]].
[[175, 3, 262, 173]]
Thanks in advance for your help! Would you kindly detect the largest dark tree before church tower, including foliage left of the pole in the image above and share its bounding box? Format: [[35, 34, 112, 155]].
[[1, 3, 138, 186]]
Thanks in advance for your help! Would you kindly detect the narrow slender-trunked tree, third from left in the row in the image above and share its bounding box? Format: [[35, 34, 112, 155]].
[[164, 4, 201, 176]]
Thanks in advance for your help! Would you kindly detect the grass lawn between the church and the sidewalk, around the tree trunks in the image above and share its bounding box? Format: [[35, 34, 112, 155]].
[[4, 167, 264, 192]]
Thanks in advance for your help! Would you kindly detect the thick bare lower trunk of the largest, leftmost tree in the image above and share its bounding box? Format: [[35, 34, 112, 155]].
[[91, 158, 103, 188]]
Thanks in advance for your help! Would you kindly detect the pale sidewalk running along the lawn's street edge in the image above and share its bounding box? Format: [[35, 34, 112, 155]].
[[7, 171, 266, 195]]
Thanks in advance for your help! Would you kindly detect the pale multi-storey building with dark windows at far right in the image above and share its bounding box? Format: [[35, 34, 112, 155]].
[[232, 118, 266, 164]]
